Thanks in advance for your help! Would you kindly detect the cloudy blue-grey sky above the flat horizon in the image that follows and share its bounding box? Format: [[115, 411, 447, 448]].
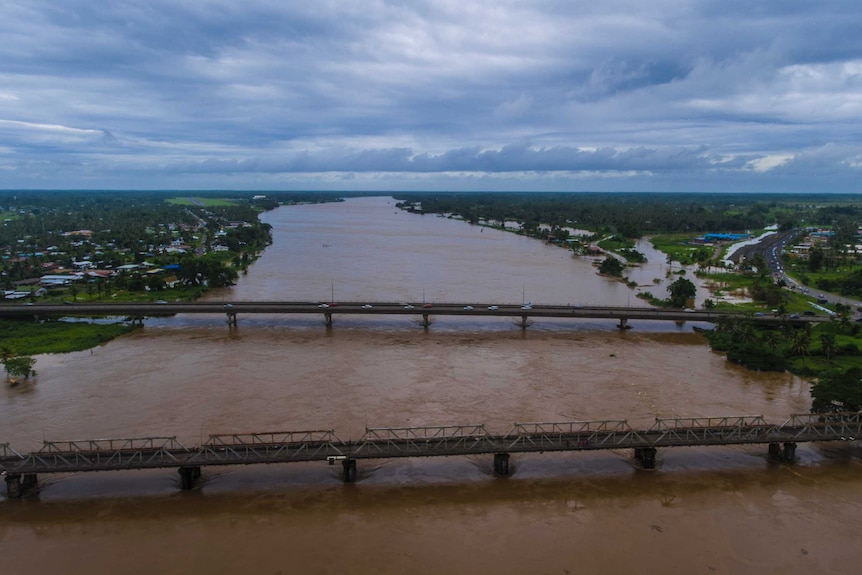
[[0, 0, 862, 193]]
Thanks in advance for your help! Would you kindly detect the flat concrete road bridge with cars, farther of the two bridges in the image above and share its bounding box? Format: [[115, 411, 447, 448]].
[[0, 301, 829, 327]]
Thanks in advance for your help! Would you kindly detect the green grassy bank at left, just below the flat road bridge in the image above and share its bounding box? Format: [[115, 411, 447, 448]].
[[0, 320, 137, 355]]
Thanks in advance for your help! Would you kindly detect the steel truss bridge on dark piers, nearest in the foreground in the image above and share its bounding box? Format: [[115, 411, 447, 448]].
[[0, 412, 862, 498]]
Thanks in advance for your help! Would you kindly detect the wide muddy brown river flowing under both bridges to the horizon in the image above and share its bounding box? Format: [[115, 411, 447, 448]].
[[0, 198, 862, 575]]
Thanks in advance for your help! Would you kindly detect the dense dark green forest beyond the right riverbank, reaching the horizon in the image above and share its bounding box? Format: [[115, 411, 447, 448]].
[[395, 192, 862, 238]]
